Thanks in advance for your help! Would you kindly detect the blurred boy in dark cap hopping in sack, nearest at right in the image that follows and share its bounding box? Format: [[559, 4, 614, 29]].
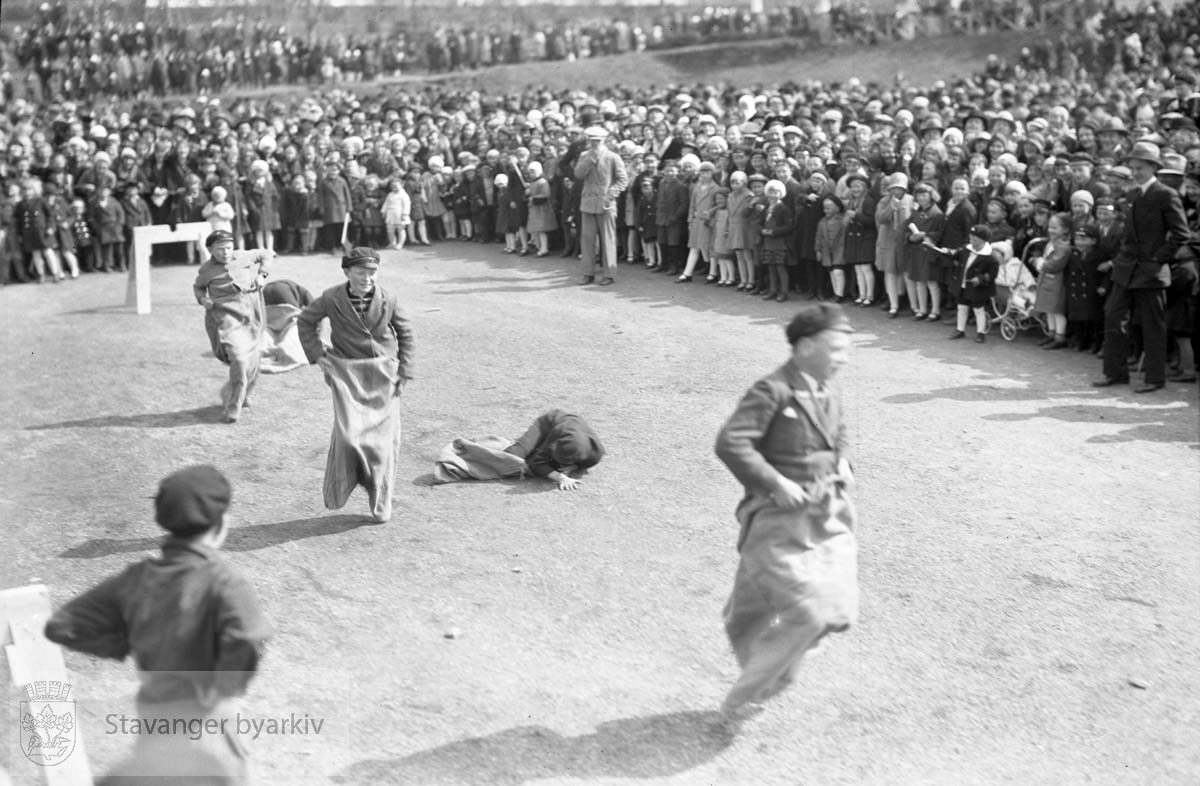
[[716, 304, 858, 719]]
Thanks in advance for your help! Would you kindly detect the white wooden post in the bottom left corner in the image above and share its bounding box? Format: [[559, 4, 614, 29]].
[[0, 584, 92, 786]]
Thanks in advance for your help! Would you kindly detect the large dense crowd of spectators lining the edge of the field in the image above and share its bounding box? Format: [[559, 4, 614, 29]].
[[0, 4, 1200, 381]]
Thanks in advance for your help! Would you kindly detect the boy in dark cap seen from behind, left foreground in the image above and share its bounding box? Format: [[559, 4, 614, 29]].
[[46, 466, 271, 782]]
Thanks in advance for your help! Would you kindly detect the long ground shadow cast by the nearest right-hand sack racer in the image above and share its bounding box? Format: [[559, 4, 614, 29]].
[[334, 710, 733, 786]]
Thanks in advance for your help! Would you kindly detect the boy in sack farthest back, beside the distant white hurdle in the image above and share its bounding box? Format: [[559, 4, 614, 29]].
[[192, 229, 275, 424]]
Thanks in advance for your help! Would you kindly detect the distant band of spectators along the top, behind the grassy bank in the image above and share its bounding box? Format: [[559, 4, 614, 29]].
[[0, 0, 1104, 103]]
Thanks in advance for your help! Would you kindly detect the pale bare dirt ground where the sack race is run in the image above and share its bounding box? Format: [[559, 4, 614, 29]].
[[0, 244, 1200, 786]]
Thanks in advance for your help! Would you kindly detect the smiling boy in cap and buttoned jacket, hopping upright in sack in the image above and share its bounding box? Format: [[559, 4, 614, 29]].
[[296, 247, 413, 522]]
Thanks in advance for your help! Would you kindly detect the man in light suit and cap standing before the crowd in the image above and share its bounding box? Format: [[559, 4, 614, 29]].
[[575, 126, 629, 286]]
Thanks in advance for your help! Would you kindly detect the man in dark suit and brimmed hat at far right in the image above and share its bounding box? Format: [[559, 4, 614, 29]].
[[1092, 142, 1188, 394]]
